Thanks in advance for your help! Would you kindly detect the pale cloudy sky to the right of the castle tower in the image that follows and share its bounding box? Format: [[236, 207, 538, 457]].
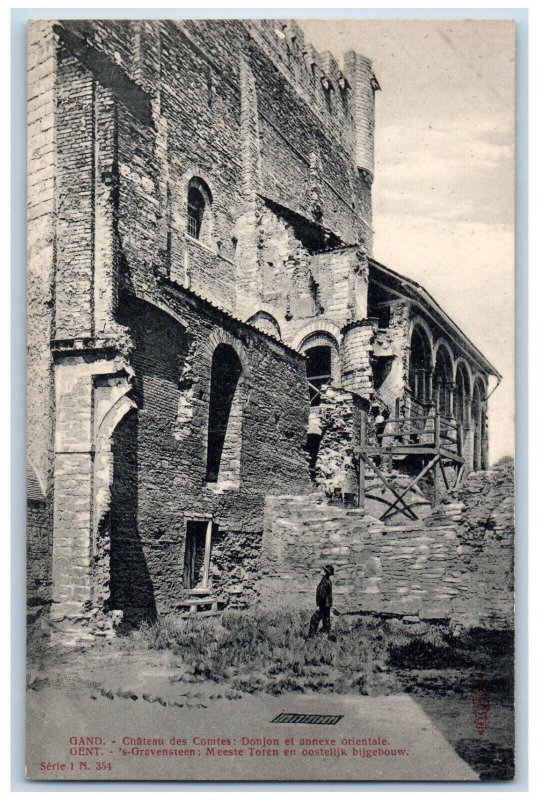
[[300, 20, 514, 463]]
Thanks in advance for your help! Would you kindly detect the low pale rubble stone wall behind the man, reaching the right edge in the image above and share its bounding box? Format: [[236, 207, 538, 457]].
[[259, 488, 513, 627]]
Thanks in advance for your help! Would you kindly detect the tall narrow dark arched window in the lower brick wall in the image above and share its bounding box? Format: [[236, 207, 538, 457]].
[[206, 344, 242, 483]]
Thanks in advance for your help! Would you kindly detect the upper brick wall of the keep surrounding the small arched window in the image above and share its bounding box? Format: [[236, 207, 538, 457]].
[[53, 20, 371, 322]]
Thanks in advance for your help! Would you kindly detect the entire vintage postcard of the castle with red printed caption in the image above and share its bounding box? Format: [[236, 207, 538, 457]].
[[26, 19, 515, 781]]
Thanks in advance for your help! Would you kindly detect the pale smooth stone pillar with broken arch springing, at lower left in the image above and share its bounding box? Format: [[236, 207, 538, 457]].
[[51, 351, 134, 640]]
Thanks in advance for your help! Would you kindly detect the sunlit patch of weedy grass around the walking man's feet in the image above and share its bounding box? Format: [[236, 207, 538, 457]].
[[110, 611, 388, 694]]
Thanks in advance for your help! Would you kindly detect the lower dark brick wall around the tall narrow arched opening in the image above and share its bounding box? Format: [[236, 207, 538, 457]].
[[111, 292, 310, 616]]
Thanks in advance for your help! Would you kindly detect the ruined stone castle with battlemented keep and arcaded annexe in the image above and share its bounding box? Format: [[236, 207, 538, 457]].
[[28, 20, 500, 637]]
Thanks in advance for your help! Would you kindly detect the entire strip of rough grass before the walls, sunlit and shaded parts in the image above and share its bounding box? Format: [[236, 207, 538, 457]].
[[102, 610, 516, 694]]
